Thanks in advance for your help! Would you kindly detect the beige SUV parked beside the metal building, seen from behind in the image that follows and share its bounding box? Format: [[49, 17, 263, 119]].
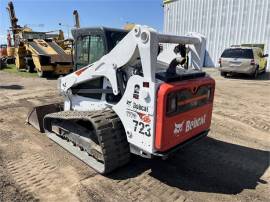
[[219, 46, 268, 78]]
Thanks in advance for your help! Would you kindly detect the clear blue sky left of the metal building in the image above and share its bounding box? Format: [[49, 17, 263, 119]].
[[0, 0, 163, 43]]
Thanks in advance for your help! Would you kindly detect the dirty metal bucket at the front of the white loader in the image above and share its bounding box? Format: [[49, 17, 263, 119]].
[[26, 103, 63, 133]]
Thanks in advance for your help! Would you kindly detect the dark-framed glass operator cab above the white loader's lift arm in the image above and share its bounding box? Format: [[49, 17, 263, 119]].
[[71, 27, 128, 71]]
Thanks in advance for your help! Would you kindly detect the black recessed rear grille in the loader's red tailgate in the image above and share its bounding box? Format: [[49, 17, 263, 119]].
[[166, 85, 213, 116]]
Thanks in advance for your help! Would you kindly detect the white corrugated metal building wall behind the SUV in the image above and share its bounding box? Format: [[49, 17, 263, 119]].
[[164, 0, 270, 71]]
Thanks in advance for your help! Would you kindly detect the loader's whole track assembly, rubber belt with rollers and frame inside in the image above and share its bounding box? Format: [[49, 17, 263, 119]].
[[44, 109, 130, 173]]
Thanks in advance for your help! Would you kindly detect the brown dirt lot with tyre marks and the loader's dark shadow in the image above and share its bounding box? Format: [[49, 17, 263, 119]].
[[0, 70, 270, 201]]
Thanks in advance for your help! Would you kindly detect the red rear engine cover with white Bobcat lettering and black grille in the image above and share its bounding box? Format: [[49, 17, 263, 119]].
[[155, 77, 215, 152]]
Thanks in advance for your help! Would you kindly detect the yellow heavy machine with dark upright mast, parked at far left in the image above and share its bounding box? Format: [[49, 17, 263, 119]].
[[7, 2, 73, 77]]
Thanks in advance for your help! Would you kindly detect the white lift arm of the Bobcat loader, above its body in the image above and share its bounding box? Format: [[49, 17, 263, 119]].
[[59, 25, 202, 95]]
